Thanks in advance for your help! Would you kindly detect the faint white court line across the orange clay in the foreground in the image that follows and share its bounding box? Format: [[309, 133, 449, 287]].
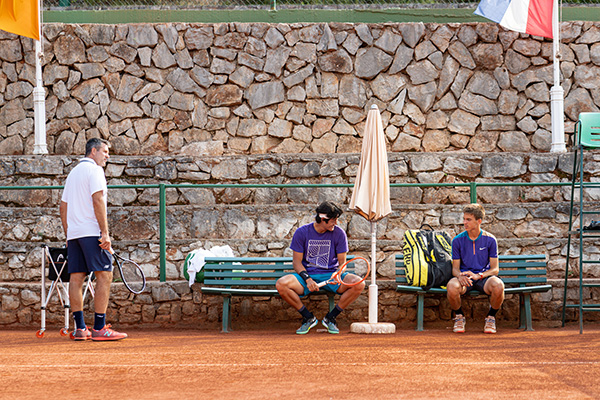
[[0, 361, 600, 370]]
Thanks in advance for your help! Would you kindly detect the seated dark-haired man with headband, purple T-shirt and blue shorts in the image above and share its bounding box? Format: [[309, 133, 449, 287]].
[[277, 201, 365, 335]]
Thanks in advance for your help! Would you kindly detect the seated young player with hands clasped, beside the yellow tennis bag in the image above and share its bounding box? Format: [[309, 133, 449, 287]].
[[447, 204, 504, 333]]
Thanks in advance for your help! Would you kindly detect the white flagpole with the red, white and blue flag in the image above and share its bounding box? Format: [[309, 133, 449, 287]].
[[550, 0, 567, 153]]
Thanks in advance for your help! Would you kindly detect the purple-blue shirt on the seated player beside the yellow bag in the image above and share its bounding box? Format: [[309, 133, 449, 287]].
[[452, 230, 498, 274]]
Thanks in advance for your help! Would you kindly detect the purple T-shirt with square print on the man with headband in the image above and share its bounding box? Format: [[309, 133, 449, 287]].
[[290, 222, 348, 274]]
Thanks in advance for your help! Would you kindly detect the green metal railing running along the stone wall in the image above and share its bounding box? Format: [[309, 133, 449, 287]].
[[0, 182, 571, 282]]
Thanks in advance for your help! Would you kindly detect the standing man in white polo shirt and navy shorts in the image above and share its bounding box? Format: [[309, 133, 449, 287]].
[[60, 138, 127, 341]]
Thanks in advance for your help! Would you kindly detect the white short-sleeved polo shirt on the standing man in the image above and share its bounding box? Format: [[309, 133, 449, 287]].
[[62, 157, 107, 240]]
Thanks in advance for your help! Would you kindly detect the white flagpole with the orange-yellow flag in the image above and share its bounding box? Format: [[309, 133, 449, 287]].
[[33, 0, 48, 154]]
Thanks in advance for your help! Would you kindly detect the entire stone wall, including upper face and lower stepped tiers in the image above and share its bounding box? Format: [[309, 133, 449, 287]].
[[0, 22, 600, 329]]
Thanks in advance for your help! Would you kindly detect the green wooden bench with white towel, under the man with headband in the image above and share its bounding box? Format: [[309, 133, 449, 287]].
[[201, 257, 354, 332]]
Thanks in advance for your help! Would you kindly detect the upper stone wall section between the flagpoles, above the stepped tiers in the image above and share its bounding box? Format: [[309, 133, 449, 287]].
[[0, 22, 600, 155]]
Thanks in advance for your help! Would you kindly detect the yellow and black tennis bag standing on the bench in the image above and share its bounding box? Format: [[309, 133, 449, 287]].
[[402, 224, 452, 290]]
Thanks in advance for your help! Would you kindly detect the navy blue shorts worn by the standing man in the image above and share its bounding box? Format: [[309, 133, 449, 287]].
[[67, 236, 113, 274]]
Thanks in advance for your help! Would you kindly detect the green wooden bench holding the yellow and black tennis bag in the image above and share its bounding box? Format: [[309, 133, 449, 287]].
[[396, 254, 552, 331]]
